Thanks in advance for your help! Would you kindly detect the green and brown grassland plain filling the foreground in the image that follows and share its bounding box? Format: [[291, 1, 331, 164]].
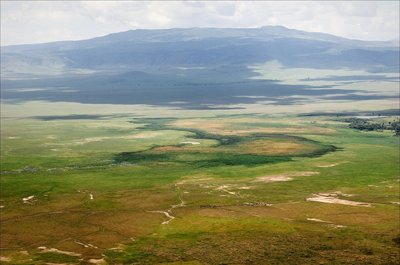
[[0, 114, 400, 264]]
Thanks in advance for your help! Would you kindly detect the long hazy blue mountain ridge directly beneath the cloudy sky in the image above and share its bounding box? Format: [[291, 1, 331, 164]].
[[1, 26, 399, 78]]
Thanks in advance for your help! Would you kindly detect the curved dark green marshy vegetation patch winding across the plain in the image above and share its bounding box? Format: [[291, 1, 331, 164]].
[[114, 118, 337, 167]]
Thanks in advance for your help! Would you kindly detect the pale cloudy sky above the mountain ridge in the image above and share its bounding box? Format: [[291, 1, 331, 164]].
[[0, 0, 400, 46]]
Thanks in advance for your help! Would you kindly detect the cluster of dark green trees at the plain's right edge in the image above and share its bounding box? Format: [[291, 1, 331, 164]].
[[345, 118, 400, 136]]
